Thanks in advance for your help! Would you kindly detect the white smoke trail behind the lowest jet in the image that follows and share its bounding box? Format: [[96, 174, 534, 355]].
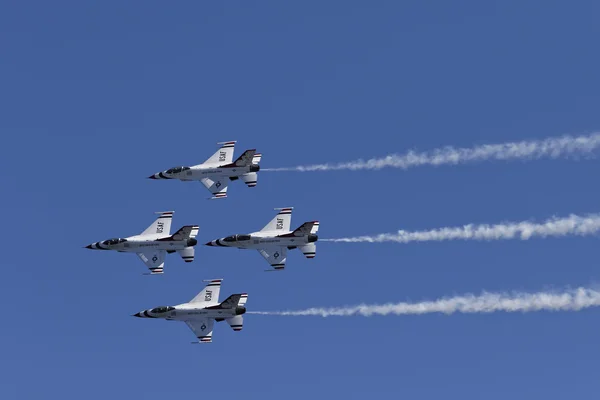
[[248, 287, 600, 317]]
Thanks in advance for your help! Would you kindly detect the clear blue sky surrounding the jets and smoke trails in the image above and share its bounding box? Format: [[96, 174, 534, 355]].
[[0, 1, 600, 400]]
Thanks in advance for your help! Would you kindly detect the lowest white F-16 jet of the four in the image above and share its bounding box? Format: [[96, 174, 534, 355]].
[[133, 279, 248, 343]]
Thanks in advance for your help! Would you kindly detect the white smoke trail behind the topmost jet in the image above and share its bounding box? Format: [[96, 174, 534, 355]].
[[261, 132, 600, 172]]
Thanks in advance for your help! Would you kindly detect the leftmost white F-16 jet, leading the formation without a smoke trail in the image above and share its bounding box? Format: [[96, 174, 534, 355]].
[[86, 211, 198, 274]]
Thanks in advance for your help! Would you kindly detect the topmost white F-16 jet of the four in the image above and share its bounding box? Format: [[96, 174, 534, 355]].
[[149, 141, 262, 199]]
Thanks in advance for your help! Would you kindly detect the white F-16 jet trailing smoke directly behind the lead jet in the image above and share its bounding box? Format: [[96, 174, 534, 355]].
[[206, 207, 319, 270]]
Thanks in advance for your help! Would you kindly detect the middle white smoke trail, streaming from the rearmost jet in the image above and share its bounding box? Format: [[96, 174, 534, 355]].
[[320, 214, 600, 243]]
